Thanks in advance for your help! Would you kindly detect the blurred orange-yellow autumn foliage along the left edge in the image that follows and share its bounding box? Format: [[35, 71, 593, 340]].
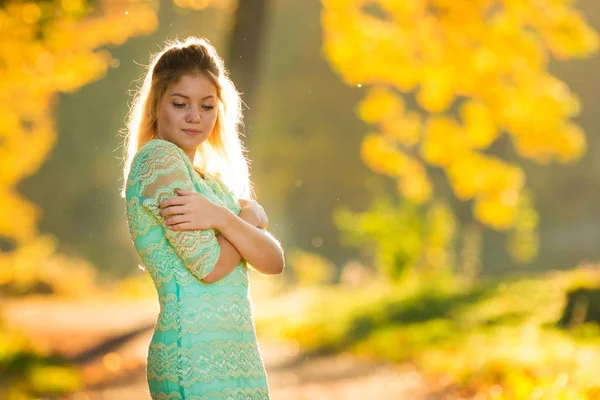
[[0, 0, 157, 295]]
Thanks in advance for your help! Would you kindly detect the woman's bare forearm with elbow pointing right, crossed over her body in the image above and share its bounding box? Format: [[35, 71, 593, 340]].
[[215, 207, 285, 275]]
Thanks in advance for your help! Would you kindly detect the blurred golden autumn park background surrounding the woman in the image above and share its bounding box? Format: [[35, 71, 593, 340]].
[[0, 0, 600, 399]]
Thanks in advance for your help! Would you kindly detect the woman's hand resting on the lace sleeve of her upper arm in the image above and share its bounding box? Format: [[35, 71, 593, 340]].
[[159, 189, 221, 230]]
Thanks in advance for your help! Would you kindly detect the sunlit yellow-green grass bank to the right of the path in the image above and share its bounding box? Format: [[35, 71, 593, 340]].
[[257, 268, 600, 399]]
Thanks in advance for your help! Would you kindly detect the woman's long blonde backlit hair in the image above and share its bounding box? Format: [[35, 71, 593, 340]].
[[121, 37, 252, 197]]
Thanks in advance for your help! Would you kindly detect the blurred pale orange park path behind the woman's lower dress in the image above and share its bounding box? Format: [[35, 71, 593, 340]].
[[3, 299, 442, 400]]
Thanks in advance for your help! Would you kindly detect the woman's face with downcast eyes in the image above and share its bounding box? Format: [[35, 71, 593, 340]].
[[156, 74, 219, 162]]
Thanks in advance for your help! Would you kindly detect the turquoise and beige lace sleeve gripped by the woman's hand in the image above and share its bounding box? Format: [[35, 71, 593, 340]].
[[139, 140, 221, 280]]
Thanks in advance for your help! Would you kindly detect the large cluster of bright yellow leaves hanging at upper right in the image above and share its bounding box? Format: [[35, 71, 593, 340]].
[[321, 0, 599, 234]]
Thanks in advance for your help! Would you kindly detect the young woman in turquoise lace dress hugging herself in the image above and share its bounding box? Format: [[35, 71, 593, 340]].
[[124, 38, 284, 400]]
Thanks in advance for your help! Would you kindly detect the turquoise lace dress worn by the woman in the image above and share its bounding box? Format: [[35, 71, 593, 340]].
[[126, 139, 269, 400]]
